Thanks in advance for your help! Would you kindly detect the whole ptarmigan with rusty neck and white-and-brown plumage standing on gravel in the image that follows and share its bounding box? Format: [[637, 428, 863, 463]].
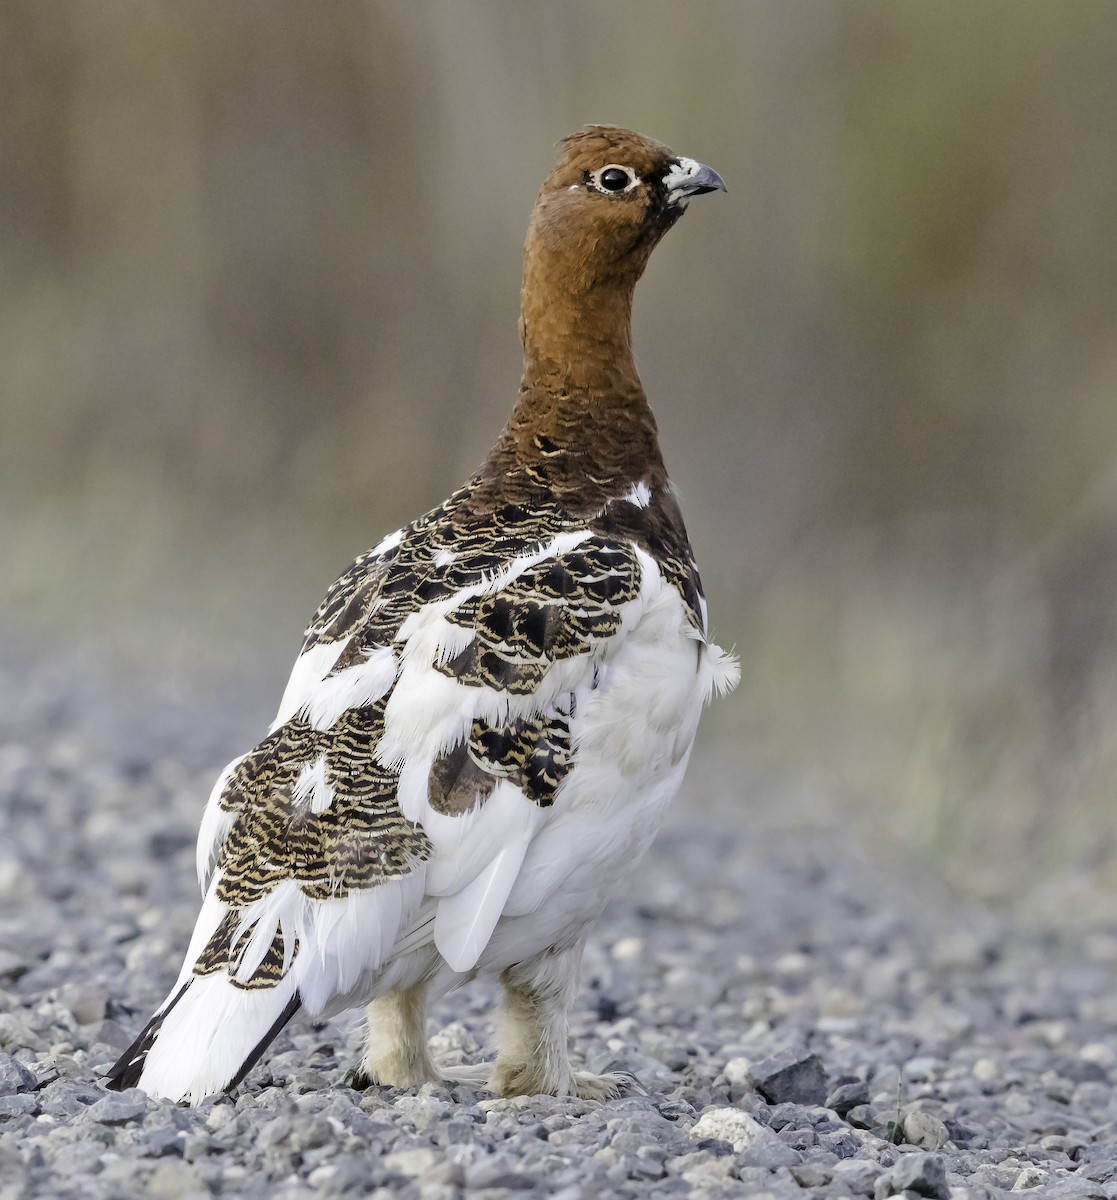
[[109, 126, 738, 1102]]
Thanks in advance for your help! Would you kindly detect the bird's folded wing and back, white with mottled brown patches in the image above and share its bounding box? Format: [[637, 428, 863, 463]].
[[176, 496, 642, 1012]]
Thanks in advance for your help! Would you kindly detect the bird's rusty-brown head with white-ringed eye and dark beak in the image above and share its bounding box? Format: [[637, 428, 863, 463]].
[[527, 125, 726, 287]]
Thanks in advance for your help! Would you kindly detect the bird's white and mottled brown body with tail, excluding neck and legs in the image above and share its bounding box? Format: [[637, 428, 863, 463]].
[[115, 487, 735, 1100]]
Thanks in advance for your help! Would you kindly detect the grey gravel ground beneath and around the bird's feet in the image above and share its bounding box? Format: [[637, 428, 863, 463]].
[[0, 656, 1117, 1200]]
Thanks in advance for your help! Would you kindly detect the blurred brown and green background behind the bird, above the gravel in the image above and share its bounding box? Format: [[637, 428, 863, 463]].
[[0, 0, 1117, 908]]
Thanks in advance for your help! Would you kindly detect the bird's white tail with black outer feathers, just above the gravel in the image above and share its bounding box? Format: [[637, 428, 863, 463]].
[[107, 972, 301, 1104]]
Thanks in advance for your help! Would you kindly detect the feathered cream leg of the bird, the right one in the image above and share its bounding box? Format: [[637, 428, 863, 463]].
[[490, 938, 632, 1100]]
